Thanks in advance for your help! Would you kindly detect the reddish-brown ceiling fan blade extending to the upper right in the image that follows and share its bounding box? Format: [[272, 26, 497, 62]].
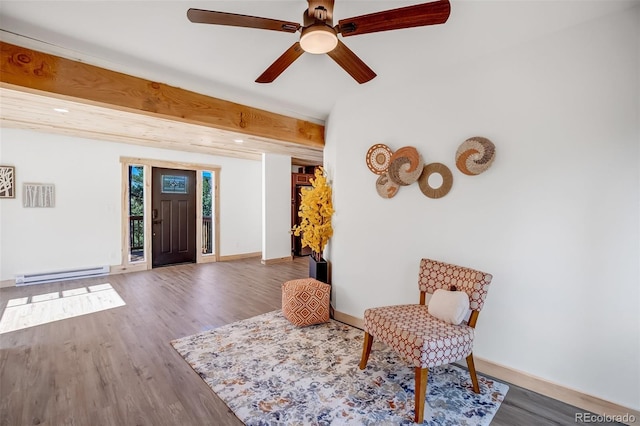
[[338, 0, 451, 37]]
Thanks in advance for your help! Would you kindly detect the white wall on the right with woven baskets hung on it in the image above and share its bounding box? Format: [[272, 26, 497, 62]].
[[325, 6, 640, 409]]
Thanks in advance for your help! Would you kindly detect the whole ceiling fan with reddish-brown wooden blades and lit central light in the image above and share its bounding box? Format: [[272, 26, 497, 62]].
[[187, 0, 451, 84]]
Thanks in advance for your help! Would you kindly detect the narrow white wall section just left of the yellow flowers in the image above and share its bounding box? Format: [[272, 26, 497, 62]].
[[262, 154, 291, 260]]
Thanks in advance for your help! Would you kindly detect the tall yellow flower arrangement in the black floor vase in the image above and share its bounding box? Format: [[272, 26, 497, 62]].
[[292, 167, 334, 261]]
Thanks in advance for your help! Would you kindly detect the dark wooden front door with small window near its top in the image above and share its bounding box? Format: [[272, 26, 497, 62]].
[[151, 167, 196, 267]]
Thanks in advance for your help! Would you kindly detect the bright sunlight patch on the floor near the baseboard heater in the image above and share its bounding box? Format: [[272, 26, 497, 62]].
[[0, 283, 126, 334]]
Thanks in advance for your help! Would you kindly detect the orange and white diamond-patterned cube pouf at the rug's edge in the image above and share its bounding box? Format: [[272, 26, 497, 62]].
[[282, 278, 331, 327]]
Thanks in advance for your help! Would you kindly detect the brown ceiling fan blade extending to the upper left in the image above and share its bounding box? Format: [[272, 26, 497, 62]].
[[187, 9, 300, 33]]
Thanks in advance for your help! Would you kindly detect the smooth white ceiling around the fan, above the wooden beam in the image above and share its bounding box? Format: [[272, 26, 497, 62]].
[[0, 0, 640, 160]]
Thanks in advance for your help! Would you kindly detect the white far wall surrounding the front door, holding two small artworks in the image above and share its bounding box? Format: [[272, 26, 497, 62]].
[[0, 128, 262, 280]]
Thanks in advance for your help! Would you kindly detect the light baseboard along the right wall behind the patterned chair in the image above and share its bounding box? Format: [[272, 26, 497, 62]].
[[334, 310, 640, 424]]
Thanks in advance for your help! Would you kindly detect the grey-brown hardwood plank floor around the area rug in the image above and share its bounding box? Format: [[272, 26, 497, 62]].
[[0, 258, 620, 426]]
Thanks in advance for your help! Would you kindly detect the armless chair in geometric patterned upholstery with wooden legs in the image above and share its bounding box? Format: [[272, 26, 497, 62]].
[[360, 259, 492, 423]]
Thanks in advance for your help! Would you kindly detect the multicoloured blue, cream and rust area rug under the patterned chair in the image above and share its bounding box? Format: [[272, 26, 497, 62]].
[[171, 311, 509, 426]]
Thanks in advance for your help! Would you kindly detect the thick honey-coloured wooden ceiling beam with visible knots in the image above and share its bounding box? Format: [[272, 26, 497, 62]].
[[0, 41, 324, 149]]
